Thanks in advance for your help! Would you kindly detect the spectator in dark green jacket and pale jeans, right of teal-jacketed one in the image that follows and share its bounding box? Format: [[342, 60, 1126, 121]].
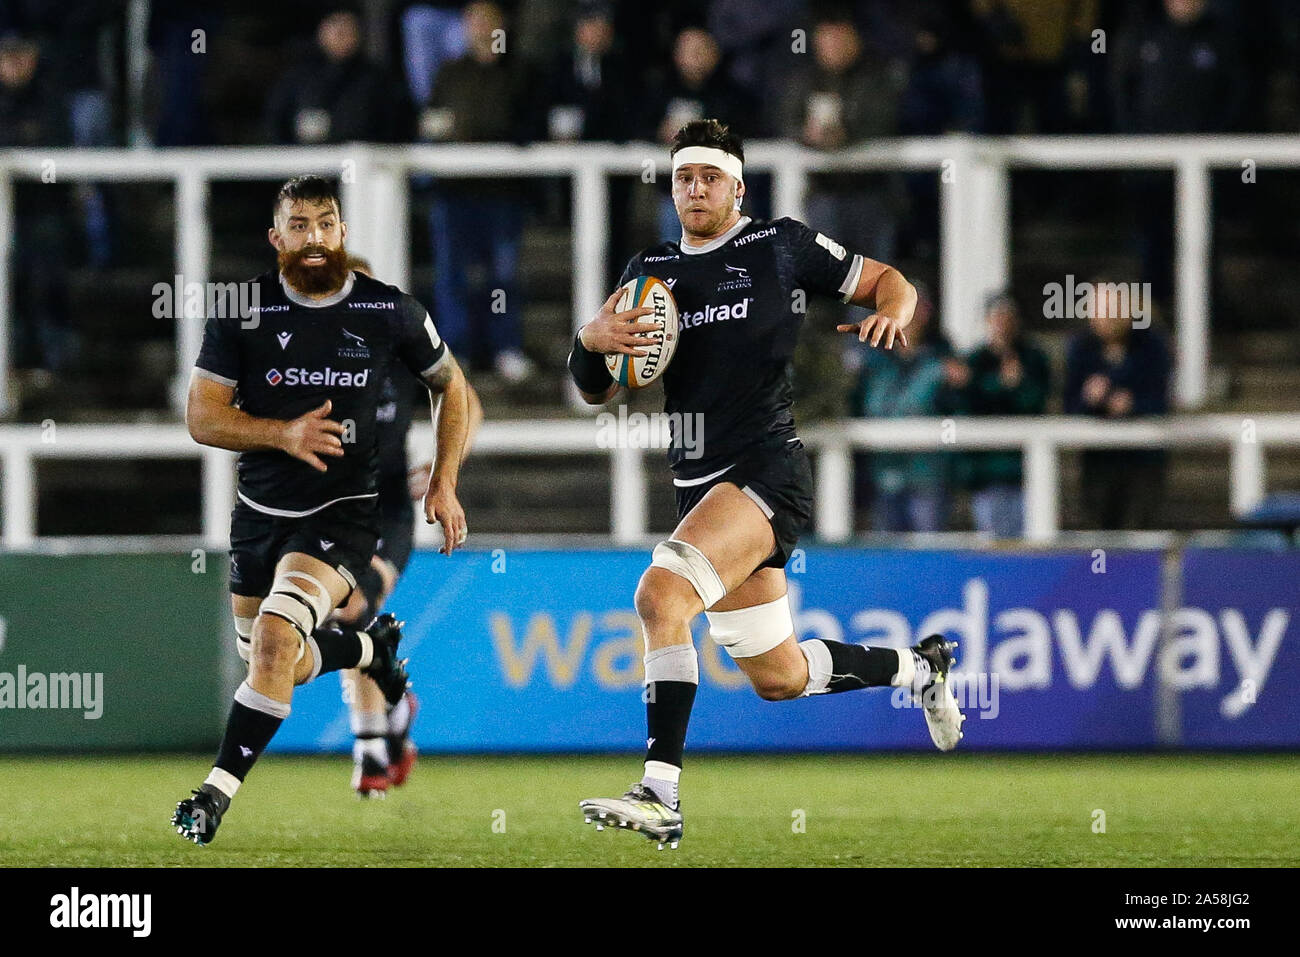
[[962, 293, 1052, 538]]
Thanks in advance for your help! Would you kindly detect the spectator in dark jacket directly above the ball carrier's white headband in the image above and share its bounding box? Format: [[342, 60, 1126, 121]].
[[645, 26, 758, 242]]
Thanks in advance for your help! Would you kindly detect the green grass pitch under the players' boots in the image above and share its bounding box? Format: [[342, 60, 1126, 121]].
[[0, 754, 1300, 867]]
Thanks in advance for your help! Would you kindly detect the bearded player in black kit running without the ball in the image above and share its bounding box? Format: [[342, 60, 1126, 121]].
[[172, 176, 467, 844]]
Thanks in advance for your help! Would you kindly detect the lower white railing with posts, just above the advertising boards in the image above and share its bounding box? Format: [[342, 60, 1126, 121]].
[[0, 413, 1300, 549]]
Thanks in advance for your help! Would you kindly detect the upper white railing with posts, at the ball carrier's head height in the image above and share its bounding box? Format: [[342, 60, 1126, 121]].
[[0, 134, 1300, 416]]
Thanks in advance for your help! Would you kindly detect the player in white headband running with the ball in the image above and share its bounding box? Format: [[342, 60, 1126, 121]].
[[569, 120, 965, 848]]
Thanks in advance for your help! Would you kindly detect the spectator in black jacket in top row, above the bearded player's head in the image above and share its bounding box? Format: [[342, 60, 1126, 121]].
[[265, 9, 413, 144]]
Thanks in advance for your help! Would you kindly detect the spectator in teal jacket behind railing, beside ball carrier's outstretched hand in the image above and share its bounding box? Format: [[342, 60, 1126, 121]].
[[858, 286, 956, 532]]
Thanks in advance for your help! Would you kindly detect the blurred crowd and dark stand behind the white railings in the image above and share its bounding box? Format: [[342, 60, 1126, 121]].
[[0, 0, 1300, 536]]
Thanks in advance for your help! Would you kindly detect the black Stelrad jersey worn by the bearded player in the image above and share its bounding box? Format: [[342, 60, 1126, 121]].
[[195, 272, 449, 518]]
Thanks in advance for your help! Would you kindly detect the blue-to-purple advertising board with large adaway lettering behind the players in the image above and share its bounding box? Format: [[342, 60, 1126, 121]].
[[274, 547, 1300, 752]]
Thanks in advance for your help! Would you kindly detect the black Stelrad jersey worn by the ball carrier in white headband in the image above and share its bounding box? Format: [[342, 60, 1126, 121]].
[[620, 216, 862, 479]]
